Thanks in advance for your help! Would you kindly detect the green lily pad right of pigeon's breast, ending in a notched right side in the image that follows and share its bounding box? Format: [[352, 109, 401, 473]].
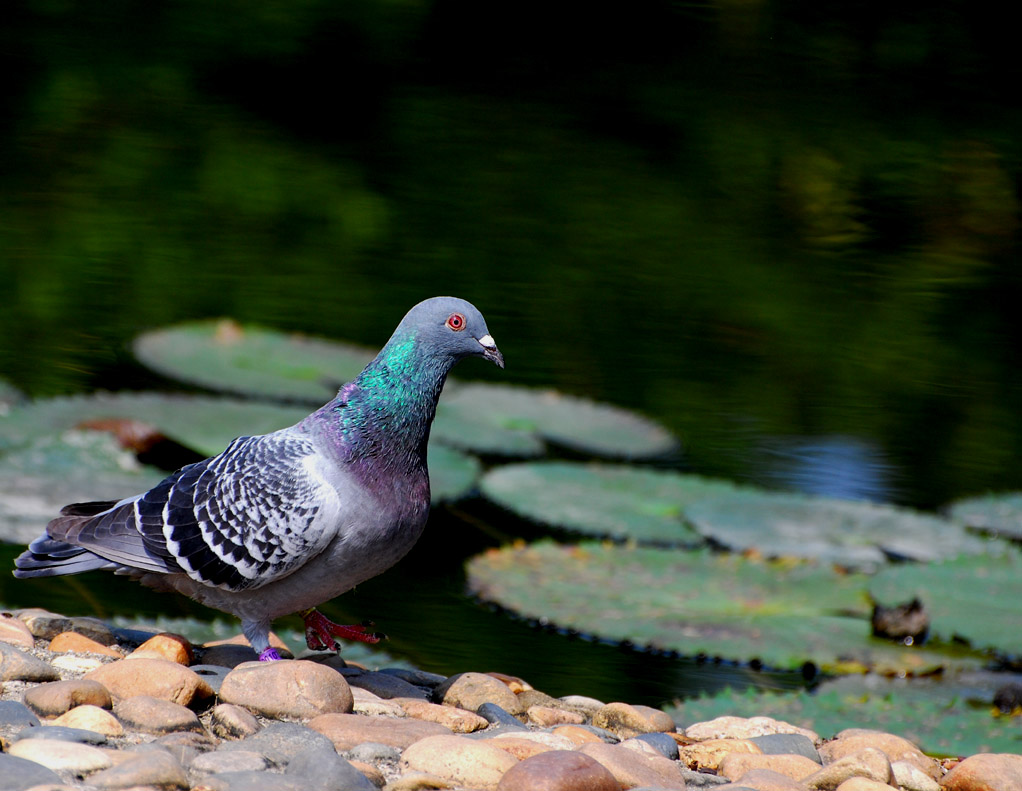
[[480, 462, 723, 545]]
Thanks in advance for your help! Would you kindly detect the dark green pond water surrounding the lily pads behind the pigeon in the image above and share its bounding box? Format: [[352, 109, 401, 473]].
[[0, 0, 1022, 702]]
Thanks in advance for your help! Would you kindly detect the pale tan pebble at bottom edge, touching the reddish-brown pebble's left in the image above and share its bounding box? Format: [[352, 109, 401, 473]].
[[401, 735, 518, 789]]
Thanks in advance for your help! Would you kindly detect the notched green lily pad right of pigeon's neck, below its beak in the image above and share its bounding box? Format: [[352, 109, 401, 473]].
[[433, 383, 678, 459]]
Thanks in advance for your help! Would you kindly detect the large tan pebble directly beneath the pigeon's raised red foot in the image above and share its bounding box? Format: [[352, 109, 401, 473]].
[[220, 659, 354, 719]]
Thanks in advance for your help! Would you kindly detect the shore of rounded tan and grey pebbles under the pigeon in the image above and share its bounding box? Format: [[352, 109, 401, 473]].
[[0, 609, 1022, 791]]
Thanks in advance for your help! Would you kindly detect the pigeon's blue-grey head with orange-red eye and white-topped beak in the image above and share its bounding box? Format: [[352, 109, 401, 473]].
[[394, 296, 504, 368]]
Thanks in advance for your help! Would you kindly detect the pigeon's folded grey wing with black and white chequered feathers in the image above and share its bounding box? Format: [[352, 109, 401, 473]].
[[47, 431, 339, 591]]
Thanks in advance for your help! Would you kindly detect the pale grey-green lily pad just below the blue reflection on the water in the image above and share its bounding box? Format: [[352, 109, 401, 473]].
[[685, 487, 989, 568]]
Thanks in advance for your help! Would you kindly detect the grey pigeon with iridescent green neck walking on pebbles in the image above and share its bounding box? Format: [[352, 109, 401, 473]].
[[14, 296, 504, 661]]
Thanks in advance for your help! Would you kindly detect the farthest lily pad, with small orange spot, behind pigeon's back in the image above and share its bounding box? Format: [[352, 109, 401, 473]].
[[134, 319, 376, 404]]
